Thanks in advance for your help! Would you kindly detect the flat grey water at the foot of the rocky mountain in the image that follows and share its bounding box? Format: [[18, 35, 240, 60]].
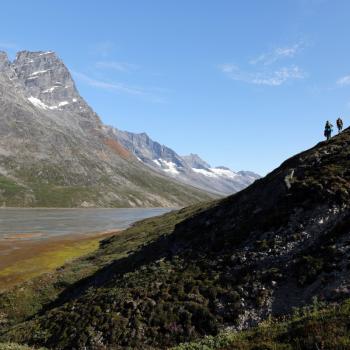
[[0, 208, 170, 239]]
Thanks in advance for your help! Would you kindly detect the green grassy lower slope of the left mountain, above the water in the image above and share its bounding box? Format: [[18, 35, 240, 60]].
[[0, 164, 213, 208]]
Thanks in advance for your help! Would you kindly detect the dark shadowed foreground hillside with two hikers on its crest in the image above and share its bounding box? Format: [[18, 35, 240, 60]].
[[0, 129, 350, 350]]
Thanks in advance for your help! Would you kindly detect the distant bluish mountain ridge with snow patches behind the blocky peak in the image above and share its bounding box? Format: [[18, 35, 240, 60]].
[[104, 126, 260, 196]]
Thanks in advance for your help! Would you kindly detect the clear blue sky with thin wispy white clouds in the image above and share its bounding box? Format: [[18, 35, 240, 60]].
[[0, 0, 350, 174]]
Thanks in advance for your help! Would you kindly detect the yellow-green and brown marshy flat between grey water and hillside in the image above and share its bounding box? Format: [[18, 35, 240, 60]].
[[0, 229, 124, 293]]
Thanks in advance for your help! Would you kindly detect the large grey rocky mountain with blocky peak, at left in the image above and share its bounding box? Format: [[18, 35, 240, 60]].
[[0, 51, 213, 207]]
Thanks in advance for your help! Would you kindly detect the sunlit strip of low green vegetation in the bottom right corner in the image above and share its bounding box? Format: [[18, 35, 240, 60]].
[[172, 299, 350, 350]]
